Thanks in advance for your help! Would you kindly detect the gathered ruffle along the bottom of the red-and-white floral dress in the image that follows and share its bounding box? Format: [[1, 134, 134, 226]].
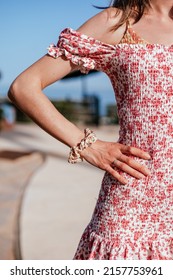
[[74, 230, 173, 260]]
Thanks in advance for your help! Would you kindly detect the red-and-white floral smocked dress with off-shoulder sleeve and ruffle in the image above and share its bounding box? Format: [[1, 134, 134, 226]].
[[48, 22, 173, 260]]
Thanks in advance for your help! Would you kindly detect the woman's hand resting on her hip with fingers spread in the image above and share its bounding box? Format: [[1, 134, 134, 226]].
[[81, 140, 150, 184]]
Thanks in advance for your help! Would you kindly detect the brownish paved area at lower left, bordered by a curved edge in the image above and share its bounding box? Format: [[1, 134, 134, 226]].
[[0, 150, 44, 260]]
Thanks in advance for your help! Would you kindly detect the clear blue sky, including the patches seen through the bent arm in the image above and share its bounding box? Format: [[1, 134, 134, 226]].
[[0, 0, 114, 114]]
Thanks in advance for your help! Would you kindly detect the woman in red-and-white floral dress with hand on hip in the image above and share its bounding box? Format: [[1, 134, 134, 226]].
[[9, 0, 173, 260]]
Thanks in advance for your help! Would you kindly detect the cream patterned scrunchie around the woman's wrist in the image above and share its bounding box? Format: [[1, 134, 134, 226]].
[[68, 128, 97, 163]]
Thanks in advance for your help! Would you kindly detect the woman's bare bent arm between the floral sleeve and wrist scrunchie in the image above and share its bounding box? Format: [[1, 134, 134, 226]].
[[8, 55, 84, 146]]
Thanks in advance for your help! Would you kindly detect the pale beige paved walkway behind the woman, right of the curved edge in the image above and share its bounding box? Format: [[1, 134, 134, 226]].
[[0, 124, 119, 260]]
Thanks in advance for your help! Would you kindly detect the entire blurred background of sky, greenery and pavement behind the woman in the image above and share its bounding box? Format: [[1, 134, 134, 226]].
[[0, 0, 119, 259]]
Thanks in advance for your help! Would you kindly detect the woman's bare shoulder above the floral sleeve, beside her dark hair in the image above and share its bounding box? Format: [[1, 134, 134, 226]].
[[78, 8, 126, 44]]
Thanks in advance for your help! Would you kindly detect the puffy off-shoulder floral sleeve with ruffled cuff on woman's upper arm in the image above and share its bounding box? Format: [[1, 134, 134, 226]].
[[48, 28, 114, 74]]
